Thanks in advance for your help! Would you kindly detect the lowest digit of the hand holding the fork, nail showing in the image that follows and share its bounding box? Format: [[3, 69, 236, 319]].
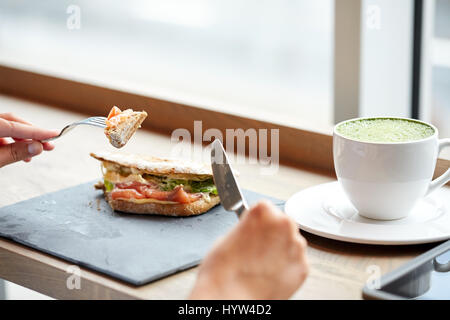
[[0, 141, 43, 168]]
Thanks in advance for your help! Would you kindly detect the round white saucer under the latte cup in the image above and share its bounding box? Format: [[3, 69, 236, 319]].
[[285, 181, 450, 245]]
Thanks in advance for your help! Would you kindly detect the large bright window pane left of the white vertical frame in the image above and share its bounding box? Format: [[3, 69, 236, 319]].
[[0, 0, 334, 129]]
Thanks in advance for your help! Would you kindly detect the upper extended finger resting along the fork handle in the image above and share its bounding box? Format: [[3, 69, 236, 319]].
[[0, 118, 58, 141]]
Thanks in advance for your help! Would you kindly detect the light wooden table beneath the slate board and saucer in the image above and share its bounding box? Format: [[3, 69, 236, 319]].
[[0, 95, 440, 299]]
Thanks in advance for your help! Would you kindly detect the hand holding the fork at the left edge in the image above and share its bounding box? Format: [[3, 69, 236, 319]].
[[0, 113, 58, 168]]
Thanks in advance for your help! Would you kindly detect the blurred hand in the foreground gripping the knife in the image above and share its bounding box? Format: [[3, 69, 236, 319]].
[[190, 202, 308, 299]]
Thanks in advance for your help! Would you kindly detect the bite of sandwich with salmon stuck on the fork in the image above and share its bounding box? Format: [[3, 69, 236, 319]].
[[105, 106, 147, 148]]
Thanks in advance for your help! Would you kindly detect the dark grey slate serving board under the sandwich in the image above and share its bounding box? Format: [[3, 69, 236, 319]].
[[0, 181, 284, 285]]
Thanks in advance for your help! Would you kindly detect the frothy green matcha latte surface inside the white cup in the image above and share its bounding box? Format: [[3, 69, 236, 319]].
[[336, 118, 434, 143]]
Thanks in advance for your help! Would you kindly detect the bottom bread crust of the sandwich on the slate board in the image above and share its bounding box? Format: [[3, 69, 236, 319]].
[[105, 192, 220, 217]]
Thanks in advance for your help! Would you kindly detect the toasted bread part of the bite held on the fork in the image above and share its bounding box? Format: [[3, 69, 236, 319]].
[[105, 111, 147, 148]]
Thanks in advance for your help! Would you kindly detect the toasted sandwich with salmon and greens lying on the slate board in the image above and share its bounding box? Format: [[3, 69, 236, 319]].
[[91, 152, 220, 216]]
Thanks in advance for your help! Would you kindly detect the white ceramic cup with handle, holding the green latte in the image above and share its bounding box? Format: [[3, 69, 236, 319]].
[[333, 117, 450, 220]]
